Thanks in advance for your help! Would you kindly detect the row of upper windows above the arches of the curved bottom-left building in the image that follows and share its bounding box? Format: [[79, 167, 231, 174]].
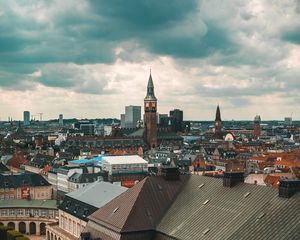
[[0, 208, 55, 217]]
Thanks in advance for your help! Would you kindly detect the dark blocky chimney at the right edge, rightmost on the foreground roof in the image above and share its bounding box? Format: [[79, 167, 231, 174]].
[[278, 179, 300, 198]]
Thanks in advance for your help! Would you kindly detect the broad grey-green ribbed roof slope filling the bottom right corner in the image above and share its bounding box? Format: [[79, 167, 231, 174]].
[[156, 176, 300, 240]]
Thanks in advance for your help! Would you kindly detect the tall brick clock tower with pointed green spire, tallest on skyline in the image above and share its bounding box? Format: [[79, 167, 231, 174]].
[[144, 72, 157, 148]]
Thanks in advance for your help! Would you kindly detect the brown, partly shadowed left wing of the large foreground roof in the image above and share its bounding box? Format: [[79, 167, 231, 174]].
[[89, 176, 188, 232]]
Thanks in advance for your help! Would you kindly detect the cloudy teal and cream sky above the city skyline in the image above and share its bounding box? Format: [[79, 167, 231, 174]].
[[0, 0, 300, 120]]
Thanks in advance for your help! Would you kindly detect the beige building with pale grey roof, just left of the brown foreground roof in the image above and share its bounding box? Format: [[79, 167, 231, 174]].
[[46, 181, 127, 240]]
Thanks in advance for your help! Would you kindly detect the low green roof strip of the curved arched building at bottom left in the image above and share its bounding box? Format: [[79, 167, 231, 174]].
[[0, 199, 57, 209]]
